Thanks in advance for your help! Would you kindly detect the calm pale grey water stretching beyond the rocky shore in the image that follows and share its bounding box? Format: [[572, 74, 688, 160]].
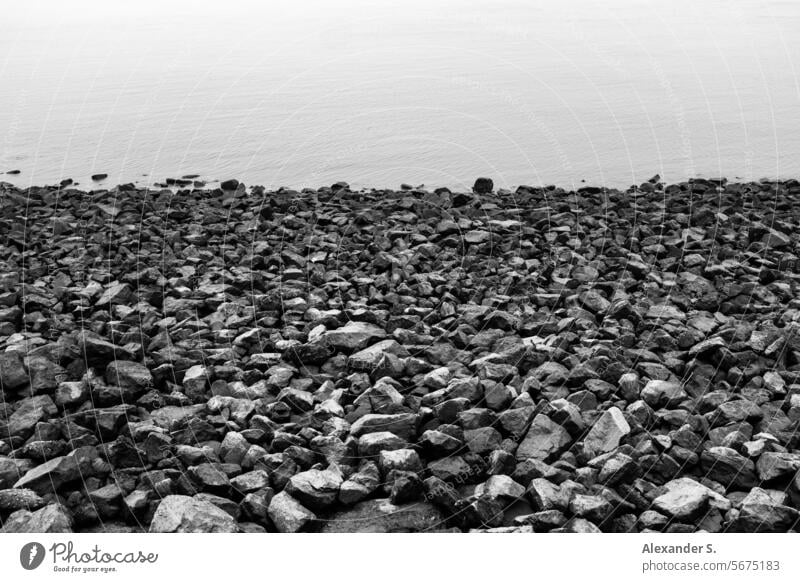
[[0, 0, 800, 188]]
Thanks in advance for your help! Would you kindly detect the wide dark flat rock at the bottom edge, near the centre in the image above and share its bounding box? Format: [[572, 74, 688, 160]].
[[321, 499, 445, 533]]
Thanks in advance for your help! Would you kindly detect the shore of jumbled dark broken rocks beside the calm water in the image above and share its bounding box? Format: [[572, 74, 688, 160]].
[[0, 177, 800, 532]]
